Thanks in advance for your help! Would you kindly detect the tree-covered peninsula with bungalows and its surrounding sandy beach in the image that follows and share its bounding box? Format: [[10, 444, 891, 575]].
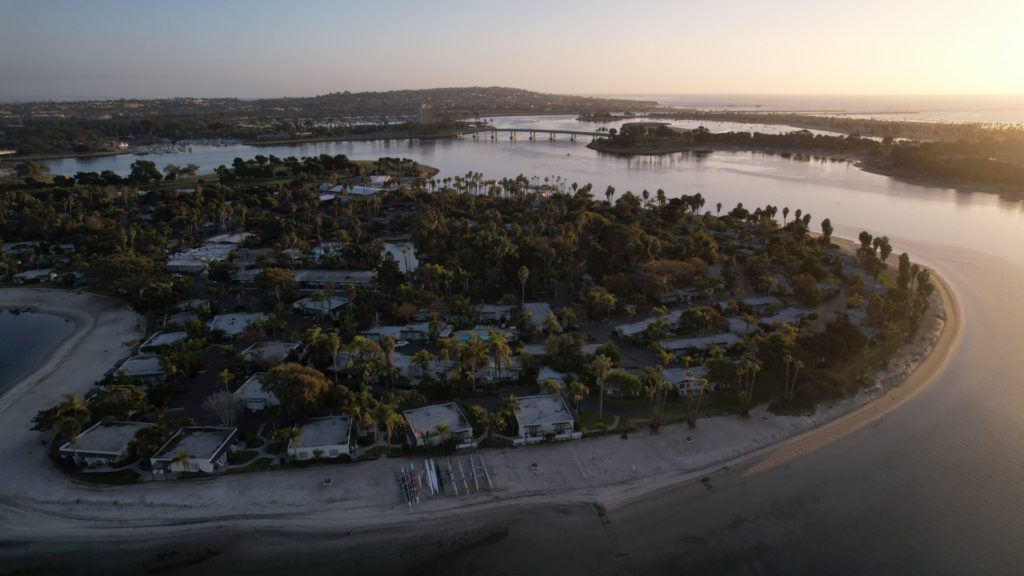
[[0, 156, 958, 571]]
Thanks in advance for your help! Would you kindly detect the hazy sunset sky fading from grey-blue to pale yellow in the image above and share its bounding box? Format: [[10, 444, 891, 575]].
[[0, 0, 1024, 99]]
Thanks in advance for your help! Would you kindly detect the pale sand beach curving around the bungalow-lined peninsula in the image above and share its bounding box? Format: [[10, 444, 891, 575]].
[[0, 264, 961, 542]]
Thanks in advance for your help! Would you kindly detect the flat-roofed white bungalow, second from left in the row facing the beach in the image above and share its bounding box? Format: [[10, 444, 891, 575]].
[[150, 426, 239, 474]]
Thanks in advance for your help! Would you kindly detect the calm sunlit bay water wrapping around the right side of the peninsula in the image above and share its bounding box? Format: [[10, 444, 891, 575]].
[[29, 114, 1024, 574]]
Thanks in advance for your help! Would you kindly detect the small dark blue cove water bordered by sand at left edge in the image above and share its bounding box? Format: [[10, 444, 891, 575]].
[[0, 310, 75, 394]]
